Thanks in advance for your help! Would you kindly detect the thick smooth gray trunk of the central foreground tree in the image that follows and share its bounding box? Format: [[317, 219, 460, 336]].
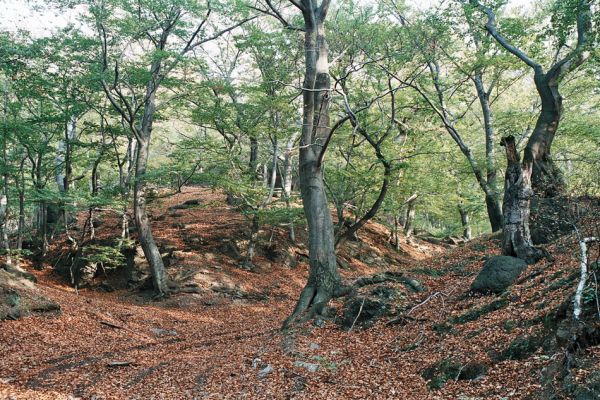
[[284, 0, 341, 327]]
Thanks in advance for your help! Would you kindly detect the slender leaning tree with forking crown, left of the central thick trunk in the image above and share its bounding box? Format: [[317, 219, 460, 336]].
[[90, 0, 249, 296]]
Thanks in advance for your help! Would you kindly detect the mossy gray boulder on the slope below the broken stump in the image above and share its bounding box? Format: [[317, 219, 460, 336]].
[[471, 256, 527, 293]]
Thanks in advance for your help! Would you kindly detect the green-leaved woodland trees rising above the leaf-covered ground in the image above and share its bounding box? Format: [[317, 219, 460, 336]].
[[0, 0, 600, 398]]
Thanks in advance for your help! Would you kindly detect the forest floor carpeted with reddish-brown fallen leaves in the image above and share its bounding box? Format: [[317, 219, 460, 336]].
[[0, 188, 600, 400]]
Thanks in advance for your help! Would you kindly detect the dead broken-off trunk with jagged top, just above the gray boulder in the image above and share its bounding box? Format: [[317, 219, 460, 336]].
[[500, 136, 544, 264]]
